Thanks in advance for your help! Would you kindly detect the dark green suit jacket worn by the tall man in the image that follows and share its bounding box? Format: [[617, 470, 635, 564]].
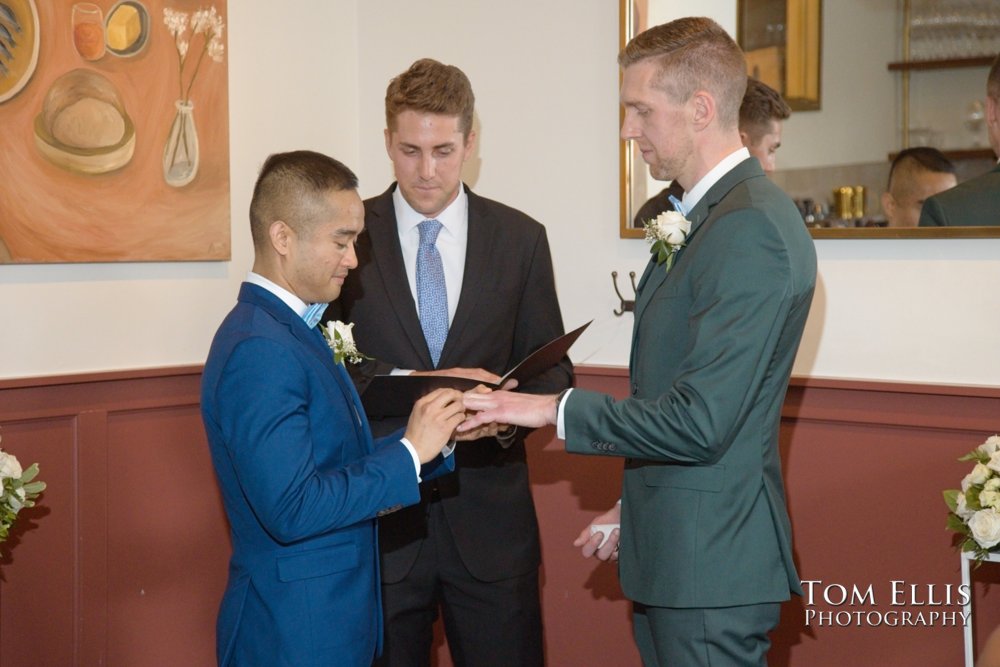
[[564, 159, 816, 607]]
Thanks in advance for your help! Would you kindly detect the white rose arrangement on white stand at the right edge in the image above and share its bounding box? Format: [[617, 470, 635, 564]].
[[944, 435, 1000, 562]]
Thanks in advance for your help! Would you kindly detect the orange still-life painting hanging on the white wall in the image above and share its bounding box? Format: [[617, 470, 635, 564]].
[[0, 0, 230, 263]]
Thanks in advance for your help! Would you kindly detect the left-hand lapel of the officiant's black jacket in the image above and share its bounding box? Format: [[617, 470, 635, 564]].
[[367, 185, 432, 368]]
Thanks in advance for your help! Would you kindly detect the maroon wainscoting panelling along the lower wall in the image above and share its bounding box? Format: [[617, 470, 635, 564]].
[[0, 366, 1000, 667]]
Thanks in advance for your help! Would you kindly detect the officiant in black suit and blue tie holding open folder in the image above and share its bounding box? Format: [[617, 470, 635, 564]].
[[331, 59, 573, 667]]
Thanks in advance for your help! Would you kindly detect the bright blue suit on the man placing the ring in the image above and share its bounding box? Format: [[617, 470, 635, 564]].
[[202, 284, 452, 667]]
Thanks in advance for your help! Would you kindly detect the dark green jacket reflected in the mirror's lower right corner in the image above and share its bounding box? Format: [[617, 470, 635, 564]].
[[919, 165, 1000, 227]]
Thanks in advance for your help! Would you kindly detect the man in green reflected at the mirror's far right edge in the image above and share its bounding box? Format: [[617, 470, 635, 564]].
[[920, 55, 1000, 227]]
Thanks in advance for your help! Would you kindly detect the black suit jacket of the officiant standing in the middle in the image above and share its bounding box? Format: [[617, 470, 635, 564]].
[[329, 185, 573, 583]]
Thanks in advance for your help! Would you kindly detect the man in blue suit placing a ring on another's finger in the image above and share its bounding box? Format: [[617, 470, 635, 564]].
[[202, 151, 472, 667]]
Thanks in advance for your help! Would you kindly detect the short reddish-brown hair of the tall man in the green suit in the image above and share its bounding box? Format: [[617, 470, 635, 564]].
[[618, 16, 747, 128]]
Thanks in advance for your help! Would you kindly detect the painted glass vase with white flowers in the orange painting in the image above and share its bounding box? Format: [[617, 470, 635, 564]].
[[163, 7, 225, 187]]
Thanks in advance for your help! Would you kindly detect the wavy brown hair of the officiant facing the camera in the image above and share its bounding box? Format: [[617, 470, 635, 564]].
[[385, 58, 476, 139]]
